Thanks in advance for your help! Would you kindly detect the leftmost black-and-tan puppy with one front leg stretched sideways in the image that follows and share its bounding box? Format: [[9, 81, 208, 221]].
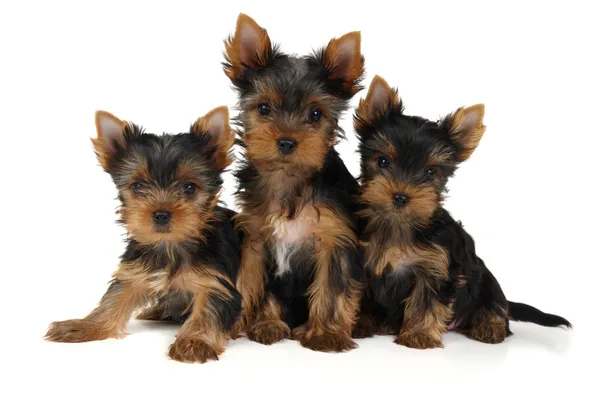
[[46, 107, 241, 362]]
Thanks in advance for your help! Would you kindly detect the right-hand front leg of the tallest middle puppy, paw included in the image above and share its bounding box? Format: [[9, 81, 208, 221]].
[[295, 242, 360, 352]]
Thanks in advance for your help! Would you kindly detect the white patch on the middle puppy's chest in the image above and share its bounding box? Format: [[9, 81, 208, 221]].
[[271, 208, 318, 276]]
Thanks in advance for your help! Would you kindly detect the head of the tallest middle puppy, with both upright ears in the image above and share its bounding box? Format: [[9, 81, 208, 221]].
[[225, 14, 364, 171]]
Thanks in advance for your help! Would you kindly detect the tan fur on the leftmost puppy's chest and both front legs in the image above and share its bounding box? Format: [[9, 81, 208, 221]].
[[46, 262, 231, 362]]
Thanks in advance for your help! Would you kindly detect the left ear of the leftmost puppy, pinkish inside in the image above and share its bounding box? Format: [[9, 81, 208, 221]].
[[92, 111, 127, 170]]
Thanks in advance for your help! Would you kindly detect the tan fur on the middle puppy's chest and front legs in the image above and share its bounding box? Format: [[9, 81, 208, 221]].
[[238, 190, 360, 351]]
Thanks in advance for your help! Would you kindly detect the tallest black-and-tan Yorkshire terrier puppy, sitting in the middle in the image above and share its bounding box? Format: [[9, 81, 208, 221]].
[[224, 14, 364, 351]]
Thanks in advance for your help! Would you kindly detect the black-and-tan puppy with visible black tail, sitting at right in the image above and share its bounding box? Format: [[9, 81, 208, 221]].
[[353, 76, 570, 348]]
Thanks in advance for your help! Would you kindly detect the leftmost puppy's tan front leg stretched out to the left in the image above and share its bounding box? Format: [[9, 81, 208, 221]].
[[45, 279, 146, 343]]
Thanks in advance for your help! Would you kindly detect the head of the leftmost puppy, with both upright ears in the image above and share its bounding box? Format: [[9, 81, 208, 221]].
[[92, 107, 233, 244]]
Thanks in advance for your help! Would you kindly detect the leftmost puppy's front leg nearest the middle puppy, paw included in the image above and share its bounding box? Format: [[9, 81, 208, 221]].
[[169, 276, 242, 363]]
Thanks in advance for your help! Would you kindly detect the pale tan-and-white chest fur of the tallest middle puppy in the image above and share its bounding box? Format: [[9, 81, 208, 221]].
[[267, 207, 319, 276]]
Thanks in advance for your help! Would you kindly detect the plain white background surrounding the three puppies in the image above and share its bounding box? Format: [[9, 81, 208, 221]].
[[0, 0, 600, 397]]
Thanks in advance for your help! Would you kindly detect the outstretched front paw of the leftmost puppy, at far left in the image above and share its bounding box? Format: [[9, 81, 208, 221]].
[[44, 319, 113, 343]]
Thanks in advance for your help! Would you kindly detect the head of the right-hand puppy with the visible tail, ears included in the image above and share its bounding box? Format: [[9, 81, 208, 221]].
[[355, 76, 485, 226]]
